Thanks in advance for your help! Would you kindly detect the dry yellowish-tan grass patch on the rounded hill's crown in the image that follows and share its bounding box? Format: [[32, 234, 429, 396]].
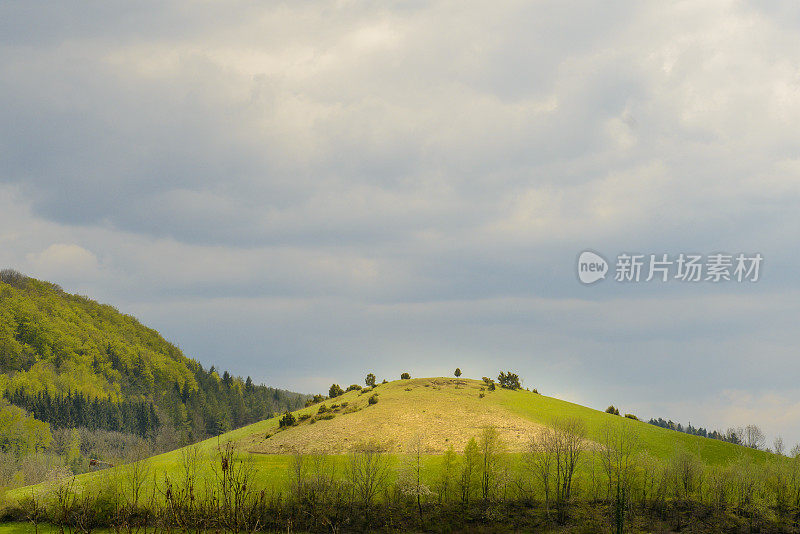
[[241, 378, 542, 454]]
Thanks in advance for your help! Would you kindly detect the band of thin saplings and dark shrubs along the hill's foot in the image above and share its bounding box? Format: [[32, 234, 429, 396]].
[[4, 418, 800, 533]]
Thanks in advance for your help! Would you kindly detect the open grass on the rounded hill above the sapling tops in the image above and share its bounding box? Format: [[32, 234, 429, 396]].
[[9, 378, 771, 506]]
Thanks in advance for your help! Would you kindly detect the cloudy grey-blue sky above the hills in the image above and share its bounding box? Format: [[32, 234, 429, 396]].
[[0, 0, 800, 445]]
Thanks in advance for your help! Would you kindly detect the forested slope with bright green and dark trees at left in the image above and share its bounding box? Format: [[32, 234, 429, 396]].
[[0, 270, 307, 474]]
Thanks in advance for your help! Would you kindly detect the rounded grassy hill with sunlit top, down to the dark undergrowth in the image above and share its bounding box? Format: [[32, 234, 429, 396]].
[[0, 377, 784, 532]]
